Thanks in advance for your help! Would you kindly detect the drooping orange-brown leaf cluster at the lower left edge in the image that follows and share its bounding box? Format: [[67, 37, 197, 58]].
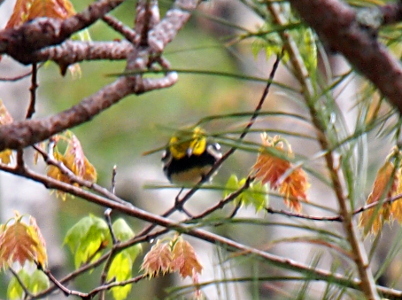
[[0, 215, 47, 266]]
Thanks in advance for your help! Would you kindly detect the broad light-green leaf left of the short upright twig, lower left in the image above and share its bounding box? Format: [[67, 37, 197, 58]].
[[64, 215, 110, 268]]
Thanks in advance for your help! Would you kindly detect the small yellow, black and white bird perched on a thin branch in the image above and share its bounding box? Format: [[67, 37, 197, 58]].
[[162, 126, 222, 185]]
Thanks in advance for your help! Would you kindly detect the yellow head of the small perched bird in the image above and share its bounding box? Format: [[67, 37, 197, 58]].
[[169, 127, 207, 159]]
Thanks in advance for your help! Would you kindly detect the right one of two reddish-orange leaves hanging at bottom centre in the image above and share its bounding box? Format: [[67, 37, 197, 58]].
[[171, 236, 202, 278]]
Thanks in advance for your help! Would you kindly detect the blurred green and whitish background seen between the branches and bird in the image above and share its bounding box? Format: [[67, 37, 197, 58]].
[[0, 0, 401, 299]]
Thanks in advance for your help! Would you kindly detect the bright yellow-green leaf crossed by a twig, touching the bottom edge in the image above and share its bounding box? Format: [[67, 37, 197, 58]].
[[107, 251, 133, 300]]
